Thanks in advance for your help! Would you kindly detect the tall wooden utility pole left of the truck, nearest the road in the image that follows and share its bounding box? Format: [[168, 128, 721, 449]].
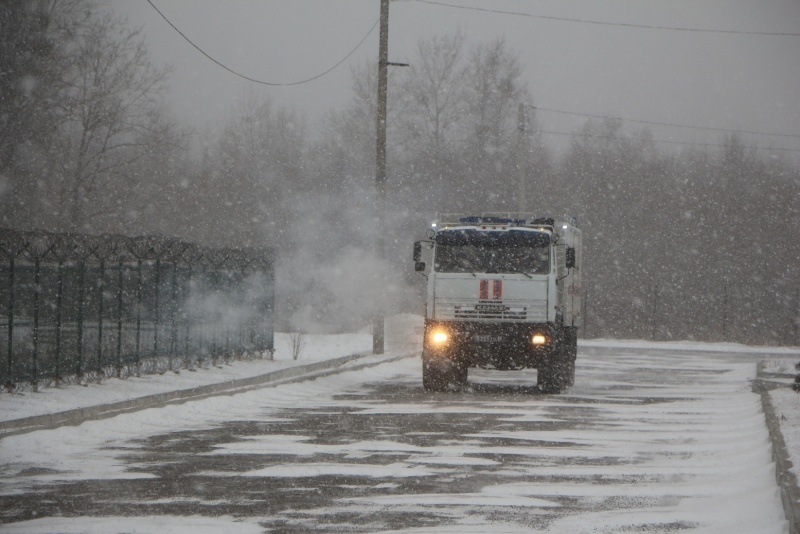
[[372, 0, 389, 354]]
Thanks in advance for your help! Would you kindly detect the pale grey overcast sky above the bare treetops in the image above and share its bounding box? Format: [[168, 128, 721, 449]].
[[107, 0, 800, 161]]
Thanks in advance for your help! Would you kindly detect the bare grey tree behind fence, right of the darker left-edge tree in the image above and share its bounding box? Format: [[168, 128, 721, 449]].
[[58, 6, 175, 231]]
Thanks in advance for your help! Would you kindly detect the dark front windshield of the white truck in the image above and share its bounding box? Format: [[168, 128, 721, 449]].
[[433, 230, 550, 274]]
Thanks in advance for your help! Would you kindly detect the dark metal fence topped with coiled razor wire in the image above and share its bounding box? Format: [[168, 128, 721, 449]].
[[0, 229, 274, 390]]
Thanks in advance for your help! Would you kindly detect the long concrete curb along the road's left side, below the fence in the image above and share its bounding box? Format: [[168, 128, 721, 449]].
[[0, 352, 414, 439]]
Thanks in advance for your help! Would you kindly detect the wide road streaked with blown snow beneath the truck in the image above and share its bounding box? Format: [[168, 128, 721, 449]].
[[0, 347, 788, 534]]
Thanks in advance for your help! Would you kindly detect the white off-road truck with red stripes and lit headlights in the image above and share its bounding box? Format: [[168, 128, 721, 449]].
[[414, 213, 582, 393]]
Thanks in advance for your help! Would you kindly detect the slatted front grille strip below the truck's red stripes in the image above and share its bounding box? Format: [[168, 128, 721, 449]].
[[434, 299, 547, 322]]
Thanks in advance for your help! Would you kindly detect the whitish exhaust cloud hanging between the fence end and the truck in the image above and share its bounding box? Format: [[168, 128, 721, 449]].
[[276, 189, 420, 334]]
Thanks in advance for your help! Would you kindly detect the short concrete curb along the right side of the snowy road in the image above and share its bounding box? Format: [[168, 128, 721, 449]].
[[757, 362, 800, 534]]
